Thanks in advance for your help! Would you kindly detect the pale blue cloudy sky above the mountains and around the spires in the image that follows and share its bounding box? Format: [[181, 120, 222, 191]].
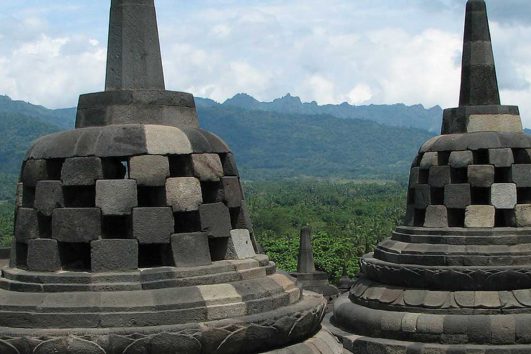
[[0, 0, 531, 127]]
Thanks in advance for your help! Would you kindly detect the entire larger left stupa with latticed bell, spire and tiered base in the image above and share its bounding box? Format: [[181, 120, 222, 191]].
[[0, 0, 342, 354]]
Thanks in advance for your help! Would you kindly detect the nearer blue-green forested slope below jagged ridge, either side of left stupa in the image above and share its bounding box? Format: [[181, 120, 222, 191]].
[[0, 96, 432, 183]]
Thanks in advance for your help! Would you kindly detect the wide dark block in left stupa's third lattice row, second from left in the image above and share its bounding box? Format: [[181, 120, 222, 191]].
[[52, 208, 101, 243]]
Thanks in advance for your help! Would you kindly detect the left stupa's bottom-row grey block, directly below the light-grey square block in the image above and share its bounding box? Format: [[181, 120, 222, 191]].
[[90, 239, 138, 272]]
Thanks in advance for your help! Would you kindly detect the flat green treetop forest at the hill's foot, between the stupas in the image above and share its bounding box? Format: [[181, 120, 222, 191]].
[[0, 179, 406, 280]]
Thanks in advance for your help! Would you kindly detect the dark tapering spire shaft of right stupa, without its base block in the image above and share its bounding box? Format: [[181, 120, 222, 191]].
[[459, 0, 500, 106]]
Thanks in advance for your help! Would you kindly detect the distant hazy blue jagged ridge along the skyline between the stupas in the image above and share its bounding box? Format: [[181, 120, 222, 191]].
[[196, 93, 442, 133]]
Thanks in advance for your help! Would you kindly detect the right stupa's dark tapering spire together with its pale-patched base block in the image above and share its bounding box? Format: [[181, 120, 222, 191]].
[[442, 0, 522, 134]]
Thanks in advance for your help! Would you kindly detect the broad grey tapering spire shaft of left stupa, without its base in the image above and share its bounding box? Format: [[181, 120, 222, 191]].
[[105, 0, 165, 91]]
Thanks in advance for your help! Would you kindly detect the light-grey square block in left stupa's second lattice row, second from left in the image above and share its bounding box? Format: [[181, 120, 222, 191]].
[[96, 179, 138, 215]]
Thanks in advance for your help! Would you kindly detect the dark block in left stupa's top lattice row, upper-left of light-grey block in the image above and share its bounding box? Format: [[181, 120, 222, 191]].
[[61, 157, 103, 186]]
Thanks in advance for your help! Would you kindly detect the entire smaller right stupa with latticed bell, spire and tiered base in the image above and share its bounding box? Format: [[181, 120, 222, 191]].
[[331, 0, 531, 354]]
